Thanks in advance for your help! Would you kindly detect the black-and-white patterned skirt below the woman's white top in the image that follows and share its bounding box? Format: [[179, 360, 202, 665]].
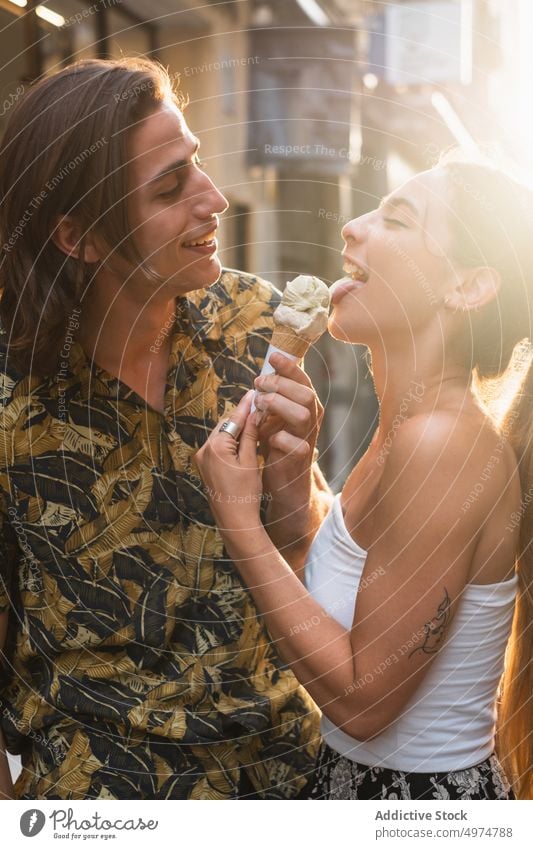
[[311, 743, 514, 801]]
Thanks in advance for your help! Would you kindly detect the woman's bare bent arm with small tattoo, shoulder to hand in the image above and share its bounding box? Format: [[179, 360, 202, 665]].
[[195, 414, 514, 739]]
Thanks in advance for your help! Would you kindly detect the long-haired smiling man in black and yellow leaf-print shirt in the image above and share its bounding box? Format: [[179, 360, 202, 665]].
[[0, 60, 327, 799]]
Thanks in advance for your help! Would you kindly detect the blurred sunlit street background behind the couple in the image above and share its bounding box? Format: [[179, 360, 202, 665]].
[[0, 0, 533, 490]]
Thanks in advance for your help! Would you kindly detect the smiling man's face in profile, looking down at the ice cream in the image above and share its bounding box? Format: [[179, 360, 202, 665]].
[[128, 102, 228, 297]]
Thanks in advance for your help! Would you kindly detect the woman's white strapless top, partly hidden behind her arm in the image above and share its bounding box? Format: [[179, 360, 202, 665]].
[[305, 495, 518, 772]]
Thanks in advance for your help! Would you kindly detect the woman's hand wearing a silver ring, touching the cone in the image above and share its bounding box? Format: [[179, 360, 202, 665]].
[[195, 391, 263, 535]]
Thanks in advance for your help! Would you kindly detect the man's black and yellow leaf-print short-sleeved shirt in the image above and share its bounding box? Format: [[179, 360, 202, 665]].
[[0, 271, 318, 798]]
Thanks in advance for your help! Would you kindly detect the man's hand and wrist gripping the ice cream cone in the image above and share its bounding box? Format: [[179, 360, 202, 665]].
[[255, 354, 328, 570]]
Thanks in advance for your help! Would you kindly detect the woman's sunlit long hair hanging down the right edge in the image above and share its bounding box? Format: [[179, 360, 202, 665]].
[[439, 158, 533, 799]]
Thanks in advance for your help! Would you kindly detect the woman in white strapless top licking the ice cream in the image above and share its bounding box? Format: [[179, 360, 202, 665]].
[[197, 157, 533, 799]]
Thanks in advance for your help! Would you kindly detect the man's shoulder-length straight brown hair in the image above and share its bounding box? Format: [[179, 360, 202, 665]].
[[0, 58, 185, 374]]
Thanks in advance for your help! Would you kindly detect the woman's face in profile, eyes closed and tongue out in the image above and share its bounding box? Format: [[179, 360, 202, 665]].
[[329, 170, 456, 344]]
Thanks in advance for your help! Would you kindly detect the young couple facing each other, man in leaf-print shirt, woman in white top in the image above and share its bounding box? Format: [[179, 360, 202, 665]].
[[0, 59, 533, 799]]
